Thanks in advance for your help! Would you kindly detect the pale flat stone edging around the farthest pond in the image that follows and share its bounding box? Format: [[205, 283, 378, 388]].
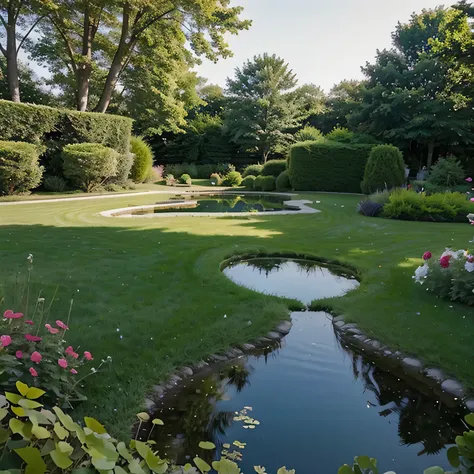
[[100, 197, 321, 219]]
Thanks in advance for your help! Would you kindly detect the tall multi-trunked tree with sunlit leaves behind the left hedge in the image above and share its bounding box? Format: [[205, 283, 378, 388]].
[[35, 0, 250, 112]]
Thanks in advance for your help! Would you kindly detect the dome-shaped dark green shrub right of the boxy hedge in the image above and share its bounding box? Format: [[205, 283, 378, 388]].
[[361, 145, 405, 194]]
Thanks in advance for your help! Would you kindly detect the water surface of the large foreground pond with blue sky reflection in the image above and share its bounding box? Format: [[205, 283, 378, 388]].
[[142, 312, 464, 474]]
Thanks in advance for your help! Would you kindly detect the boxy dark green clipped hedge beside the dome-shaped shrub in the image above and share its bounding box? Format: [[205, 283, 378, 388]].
[[288, 141, 373, 193]]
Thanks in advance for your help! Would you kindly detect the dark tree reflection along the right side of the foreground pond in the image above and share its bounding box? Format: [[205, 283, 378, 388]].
[[337, 333, 465, 455]]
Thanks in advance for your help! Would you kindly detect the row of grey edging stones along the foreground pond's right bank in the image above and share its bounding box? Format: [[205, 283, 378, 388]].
[[332, 316, 474, 412]]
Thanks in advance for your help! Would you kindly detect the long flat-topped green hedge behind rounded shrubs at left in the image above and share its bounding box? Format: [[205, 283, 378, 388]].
[[0, 100, 132, 154]]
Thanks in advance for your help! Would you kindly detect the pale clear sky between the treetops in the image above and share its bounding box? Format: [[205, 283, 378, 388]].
[[196, 0, 444, 91]]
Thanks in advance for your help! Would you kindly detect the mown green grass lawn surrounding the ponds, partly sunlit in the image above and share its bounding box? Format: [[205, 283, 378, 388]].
[[0, 194, 474, 433]]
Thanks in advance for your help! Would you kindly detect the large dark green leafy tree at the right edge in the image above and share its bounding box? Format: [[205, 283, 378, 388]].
[[349, 8, 474, 167]]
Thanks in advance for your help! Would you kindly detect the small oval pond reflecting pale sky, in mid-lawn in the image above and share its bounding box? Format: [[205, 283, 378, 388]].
[[223, 258, 359, 304]]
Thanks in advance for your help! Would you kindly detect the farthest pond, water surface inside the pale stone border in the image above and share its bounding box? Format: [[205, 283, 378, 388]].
[[129, 194, 291, 216]]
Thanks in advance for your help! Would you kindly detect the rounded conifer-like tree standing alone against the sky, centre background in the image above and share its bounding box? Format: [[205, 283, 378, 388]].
[[225, 54, 304, 162]]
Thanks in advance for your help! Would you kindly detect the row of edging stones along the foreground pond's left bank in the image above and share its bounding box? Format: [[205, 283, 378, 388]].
[[145, 320, 293, 413]]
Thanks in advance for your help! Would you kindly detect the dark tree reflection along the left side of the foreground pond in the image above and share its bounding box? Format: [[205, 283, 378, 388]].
[[147, 359, 253, 463]]
